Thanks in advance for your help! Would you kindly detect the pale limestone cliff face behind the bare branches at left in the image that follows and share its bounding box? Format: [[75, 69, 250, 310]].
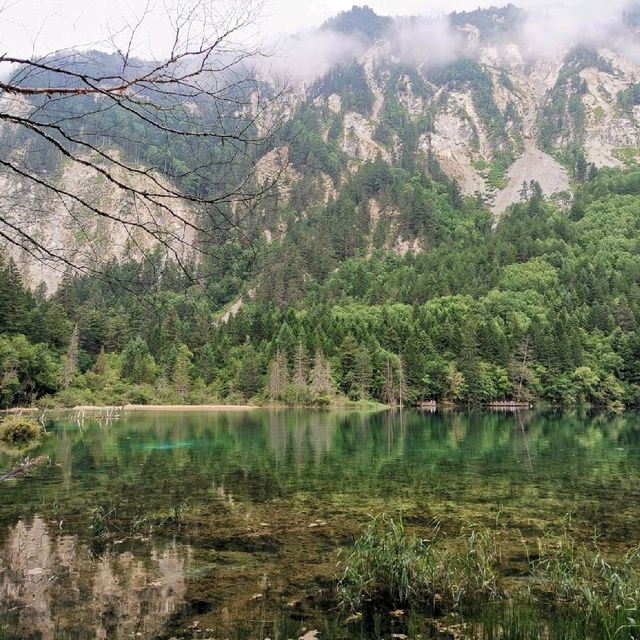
[[0, 149, 195, 292]]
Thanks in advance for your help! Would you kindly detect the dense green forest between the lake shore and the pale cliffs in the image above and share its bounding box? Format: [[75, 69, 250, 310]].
[[0, 162, 640, 407]]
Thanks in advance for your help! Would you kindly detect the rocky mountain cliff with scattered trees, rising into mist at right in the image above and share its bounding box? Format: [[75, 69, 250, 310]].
[[264, 6, 640, 214]]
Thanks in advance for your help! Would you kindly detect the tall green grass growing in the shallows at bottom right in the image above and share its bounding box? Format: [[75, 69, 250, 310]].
[[338, 515, 640, 640]]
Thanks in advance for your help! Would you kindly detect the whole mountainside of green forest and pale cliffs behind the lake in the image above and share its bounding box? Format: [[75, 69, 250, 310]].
[[0, 6, 640, 407]]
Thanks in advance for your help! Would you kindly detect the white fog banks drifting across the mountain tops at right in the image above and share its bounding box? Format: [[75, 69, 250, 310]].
[[268, 0, 640, 82]]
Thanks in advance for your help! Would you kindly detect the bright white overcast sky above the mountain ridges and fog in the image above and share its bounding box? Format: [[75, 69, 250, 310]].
[[0, 0, 577, 56]]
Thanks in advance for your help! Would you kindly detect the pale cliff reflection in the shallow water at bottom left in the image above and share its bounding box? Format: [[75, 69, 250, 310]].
[[0, 516, 190, 640]]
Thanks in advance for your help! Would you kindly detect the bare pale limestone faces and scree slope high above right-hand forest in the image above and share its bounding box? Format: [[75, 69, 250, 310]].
[[264, 37, 640, 214]]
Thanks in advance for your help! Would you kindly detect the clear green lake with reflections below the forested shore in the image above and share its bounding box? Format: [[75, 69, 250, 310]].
[[0, 410, 640, 640]]
